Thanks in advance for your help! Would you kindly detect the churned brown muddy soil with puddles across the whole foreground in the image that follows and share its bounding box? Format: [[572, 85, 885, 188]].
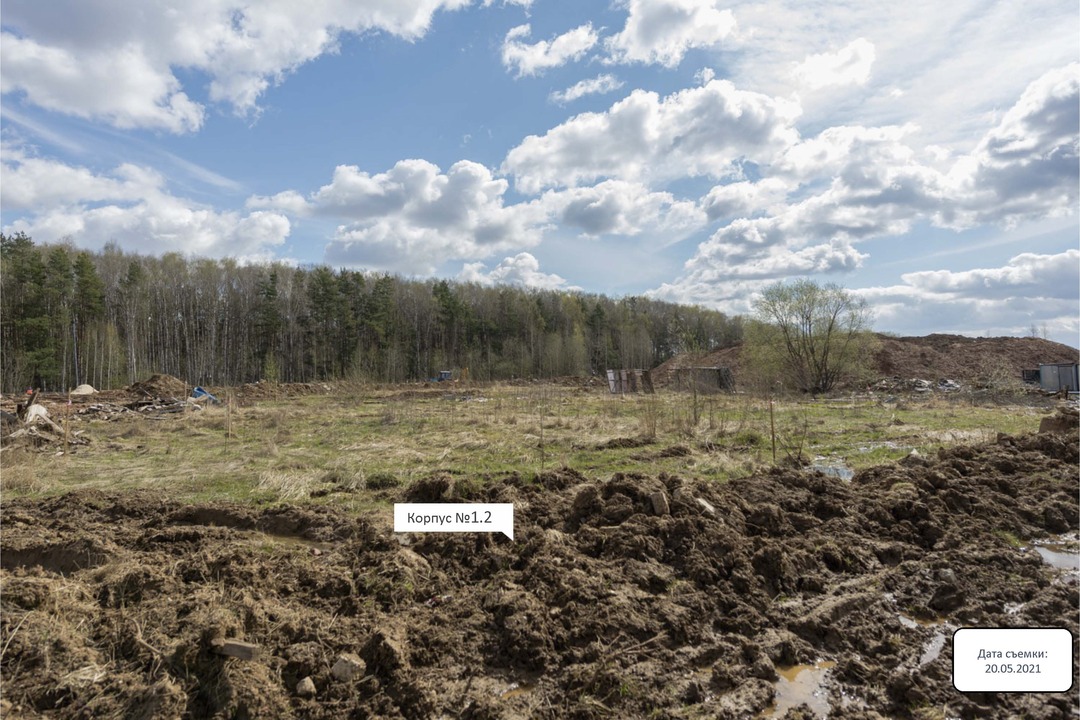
[[0, 435, 1080, 720]]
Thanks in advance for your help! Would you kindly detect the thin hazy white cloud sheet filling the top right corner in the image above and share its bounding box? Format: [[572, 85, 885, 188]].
[[724, 0, 1080, 152]]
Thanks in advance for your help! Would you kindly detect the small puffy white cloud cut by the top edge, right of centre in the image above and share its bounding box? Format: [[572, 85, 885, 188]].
[[605, 0, 735, 68]]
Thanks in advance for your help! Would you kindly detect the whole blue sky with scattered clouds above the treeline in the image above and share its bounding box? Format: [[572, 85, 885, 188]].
[[0, 0, 1080, 347]]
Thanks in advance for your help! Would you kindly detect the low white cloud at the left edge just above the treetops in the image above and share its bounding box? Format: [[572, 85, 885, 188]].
[[0, 148, 291, 259]]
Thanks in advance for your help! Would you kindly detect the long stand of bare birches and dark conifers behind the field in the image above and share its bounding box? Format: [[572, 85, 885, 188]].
[[0, 233, 743, 392]]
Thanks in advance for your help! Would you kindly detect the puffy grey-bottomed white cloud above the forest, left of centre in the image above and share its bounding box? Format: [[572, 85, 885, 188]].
[[315, 160, 543, 274]]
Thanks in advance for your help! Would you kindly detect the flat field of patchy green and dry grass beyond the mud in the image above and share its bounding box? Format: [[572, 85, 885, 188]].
[[0, 384, 1040, 502]]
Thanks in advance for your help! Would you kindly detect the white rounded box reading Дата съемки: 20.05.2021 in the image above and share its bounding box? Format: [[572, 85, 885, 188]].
[[953, 627, 1072, 693]]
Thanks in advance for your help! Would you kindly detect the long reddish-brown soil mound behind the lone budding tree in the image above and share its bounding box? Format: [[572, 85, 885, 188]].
[[652, 335, 1080, 386]]
